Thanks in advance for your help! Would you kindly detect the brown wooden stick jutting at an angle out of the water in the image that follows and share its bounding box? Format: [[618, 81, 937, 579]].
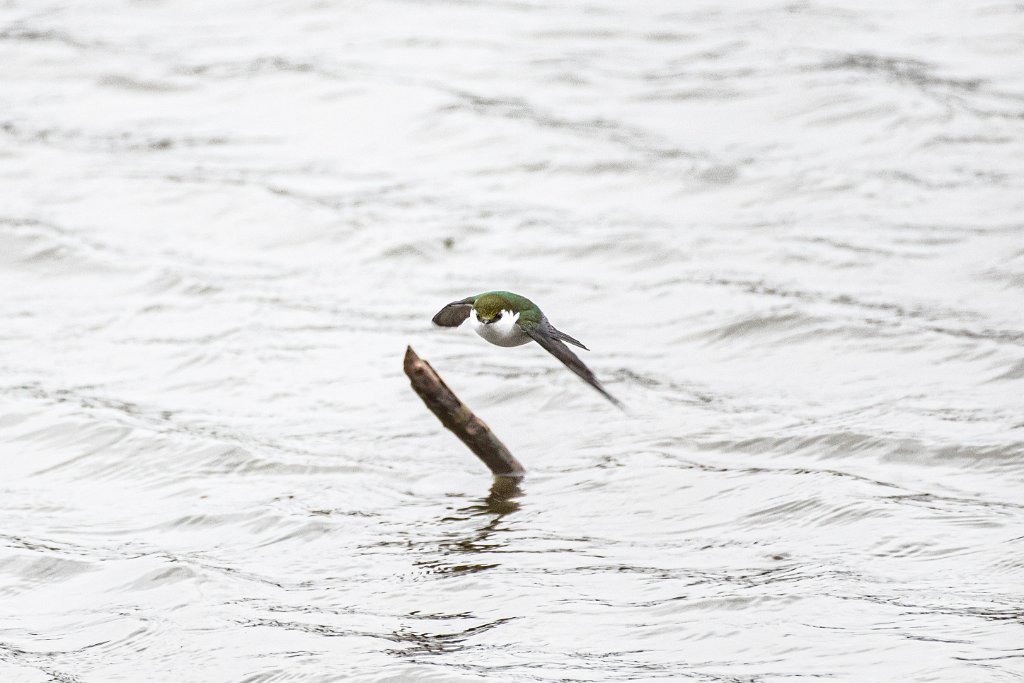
[[403, 346, 526, 477]]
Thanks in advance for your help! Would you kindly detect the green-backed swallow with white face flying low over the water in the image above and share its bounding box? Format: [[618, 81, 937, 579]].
[[433, 292, 623, 410]]
